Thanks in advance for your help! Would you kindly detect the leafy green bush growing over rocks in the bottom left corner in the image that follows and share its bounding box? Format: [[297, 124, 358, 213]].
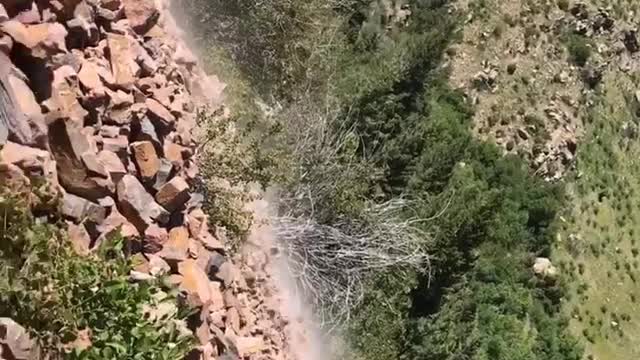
[[0, 196, 192, 360]]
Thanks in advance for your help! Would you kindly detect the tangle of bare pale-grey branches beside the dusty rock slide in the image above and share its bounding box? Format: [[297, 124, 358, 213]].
[[273, 199, 429, 330]]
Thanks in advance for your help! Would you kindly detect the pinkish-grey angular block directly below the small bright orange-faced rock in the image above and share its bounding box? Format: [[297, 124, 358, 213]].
[[117, 175, 169, 232]]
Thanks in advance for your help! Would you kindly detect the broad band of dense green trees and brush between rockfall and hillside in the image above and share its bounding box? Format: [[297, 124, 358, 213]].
[[179, 0, 588, 360]]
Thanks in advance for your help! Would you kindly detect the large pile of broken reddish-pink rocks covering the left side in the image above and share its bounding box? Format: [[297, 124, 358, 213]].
[[0, 0, 285, 359]]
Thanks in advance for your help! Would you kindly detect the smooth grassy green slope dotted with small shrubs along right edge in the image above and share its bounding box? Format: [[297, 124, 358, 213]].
[[554, 74, 640, 359]]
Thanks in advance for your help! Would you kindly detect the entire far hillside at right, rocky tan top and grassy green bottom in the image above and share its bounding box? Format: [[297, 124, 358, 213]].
[[449, 1, 640, 359]]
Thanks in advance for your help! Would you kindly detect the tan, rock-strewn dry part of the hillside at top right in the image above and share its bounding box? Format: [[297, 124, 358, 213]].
[[448, 0, 638, 181]]
